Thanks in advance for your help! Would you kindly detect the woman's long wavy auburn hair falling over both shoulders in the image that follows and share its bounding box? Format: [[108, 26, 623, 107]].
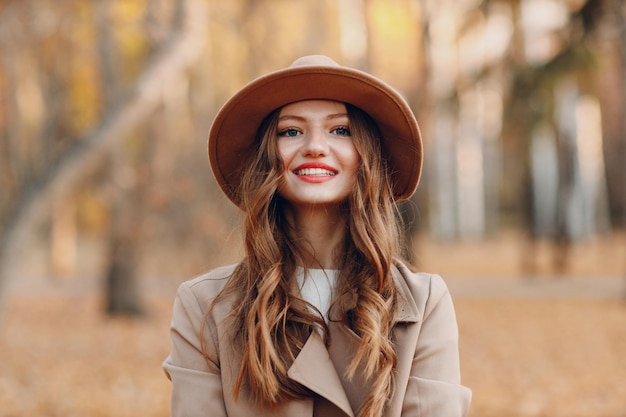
[[205, 104, 400, 417]]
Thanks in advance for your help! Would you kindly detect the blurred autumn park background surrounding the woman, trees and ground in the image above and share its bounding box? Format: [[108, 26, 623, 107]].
[[0, 0, 626, 417]]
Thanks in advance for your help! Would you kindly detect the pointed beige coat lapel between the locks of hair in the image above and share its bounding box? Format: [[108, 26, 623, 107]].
[[287, 331, 354, 417]]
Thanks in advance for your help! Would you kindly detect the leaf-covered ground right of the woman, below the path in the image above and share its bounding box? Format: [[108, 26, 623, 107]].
[[456, 299, 626, 417]]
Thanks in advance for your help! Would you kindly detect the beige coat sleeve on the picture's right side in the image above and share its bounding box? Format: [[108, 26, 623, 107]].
[[402, 275, 472, 417]]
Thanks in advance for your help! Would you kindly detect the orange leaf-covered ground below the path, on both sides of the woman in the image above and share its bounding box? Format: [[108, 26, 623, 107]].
[[0, 234, 626, 417]]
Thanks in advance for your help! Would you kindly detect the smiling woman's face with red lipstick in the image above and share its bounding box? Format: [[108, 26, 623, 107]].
[[277, 100, 359, 207]]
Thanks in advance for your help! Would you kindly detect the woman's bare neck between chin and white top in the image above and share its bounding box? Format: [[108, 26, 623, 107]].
[[289, 204, 346, 269]]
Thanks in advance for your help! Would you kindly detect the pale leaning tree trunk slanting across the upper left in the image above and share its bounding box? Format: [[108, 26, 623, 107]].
[[0, 0, 207, 307]]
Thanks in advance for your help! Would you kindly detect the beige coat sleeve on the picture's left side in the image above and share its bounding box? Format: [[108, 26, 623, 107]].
[[163, 283, 226, 417]]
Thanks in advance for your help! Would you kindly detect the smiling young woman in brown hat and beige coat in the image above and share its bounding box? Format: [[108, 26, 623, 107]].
[[164, 56, 471, 417]]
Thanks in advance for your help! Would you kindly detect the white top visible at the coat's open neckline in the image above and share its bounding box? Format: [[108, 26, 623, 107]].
[[296, 267, 339, 322]]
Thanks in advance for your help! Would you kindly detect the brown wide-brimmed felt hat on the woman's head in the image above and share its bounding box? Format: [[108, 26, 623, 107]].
[[209, 55, 422, 206]]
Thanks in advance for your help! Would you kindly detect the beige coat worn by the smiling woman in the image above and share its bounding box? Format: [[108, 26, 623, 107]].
[[163, 264, 471, 417]]
